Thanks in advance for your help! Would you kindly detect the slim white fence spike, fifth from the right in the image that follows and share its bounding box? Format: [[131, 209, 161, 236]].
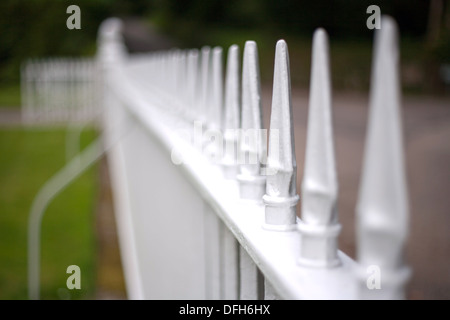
[[222, 44, 240, 179]]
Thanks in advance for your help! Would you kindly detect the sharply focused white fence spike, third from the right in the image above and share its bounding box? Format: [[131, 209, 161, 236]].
[[263, 40, 299, 231]]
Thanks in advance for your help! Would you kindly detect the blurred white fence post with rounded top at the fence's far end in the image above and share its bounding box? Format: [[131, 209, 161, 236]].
[[97, 18, 144, 300]]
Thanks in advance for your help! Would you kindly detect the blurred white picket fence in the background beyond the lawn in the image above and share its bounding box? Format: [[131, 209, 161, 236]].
[[21, 58, 100, 124]]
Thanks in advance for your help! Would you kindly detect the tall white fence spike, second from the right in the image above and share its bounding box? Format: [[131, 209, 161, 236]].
[[298, 29, 341, 267]]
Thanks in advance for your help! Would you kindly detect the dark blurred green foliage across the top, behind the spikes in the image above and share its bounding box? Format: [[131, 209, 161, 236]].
[[0, 0, 438, 91]]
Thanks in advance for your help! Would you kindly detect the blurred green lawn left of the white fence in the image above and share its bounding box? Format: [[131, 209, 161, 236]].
[[0, 128, 98, 299]]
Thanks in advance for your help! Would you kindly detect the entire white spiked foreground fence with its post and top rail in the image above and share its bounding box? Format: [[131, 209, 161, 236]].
[[99, 17, 409, 299]]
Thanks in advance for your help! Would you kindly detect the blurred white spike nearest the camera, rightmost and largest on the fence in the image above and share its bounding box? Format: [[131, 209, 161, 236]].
[[356, 16, 409, 299]]
